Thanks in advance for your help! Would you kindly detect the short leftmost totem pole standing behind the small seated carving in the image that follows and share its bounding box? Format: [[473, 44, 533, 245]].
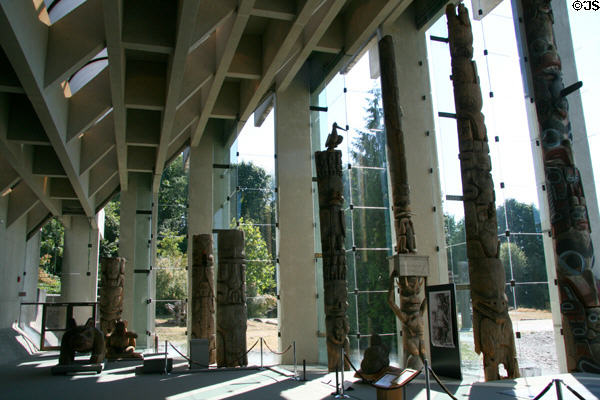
[[100, 257, 127, 335]]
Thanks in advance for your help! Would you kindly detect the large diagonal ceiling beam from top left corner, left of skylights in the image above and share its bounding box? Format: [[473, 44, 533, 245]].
[[0, 1, 95, 217]]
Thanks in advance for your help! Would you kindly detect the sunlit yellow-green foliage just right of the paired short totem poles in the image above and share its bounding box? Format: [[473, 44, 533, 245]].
[[237, 218, 276, 297]]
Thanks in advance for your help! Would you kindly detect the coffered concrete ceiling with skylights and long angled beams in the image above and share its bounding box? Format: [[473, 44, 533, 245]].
[[0, 0, 446, 236]]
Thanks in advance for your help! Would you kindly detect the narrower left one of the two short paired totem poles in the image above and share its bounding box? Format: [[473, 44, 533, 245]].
[[191, 234, 216, 364]]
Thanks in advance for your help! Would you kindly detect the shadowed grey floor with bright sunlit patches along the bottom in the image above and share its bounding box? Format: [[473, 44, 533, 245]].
[[0, 330, 600, 400]]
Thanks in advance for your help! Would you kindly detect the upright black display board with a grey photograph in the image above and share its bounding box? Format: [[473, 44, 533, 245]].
[[425, 283, 462, 379]]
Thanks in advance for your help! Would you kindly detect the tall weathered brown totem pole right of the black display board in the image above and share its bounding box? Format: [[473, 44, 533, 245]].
[[446, 4, 519, 380]]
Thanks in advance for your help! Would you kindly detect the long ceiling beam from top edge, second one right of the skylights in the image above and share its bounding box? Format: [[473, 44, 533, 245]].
[[152, 0, 202, 192]]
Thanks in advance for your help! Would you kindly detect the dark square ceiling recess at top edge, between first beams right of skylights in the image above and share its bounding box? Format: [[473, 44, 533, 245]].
[[123, 0, 179, 54]]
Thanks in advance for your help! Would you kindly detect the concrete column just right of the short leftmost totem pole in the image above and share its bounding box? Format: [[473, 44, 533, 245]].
[[119, 173, 154, 347]]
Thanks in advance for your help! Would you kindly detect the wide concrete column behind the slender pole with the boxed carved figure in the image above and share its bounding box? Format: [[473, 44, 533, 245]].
[[383, 7, 448, 357]]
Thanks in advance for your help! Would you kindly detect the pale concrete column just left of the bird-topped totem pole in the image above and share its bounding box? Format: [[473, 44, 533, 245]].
[[275, 71, 318, 363]]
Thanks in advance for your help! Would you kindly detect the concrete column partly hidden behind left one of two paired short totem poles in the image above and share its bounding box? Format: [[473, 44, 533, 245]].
[[187, 132, 215, 339]]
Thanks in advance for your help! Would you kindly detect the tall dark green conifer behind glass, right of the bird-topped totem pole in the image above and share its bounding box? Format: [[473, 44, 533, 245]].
[[344, 88, 396, 334]]
